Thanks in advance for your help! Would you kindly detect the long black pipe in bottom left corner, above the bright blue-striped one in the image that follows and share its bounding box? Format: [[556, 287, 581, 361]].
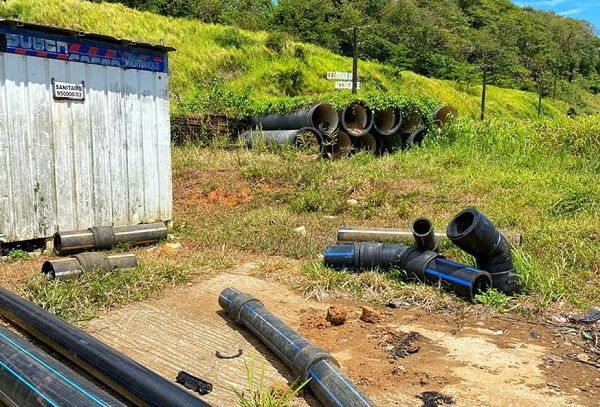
[[0, 288, 209, 407]]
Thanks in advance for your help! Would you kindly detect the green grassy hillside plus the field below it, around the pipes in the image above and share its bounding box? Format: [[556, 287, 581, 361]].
[[0, 0, 600, 311]]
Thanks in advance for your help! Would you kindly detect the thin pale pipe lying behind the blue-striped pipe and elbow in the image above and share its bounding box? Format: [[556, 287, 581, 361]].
[[337, 226, 522, 245]]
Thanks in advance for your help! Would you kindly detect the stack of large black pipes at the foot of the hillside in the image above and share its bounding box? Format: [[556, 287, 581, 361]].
[[242, 100, 458, 159]]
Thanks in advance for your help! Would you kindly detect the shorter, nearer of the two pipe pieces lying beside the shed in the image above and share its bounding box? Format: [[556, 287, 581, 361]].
[[42, 252, 138, 280]]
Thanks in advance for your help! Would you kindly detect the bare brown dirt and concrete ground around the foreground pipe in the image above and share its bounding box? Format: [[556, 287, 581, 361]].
[[87, 263, 600, 407]]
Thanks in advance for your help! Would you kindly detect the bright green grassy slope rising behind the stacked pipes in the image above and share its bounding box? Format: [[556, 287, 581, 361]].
[[0, 0, 600, 119]]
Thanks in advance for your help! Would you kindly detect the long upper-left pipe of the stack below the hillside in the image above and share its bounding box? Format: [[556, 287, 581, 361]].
[[251, 103, 339, 133]]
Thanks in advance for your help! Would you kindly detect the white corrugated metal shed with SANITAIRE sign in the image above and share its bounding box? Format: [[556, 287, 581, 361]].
[[0, 19, 173, 242]]
